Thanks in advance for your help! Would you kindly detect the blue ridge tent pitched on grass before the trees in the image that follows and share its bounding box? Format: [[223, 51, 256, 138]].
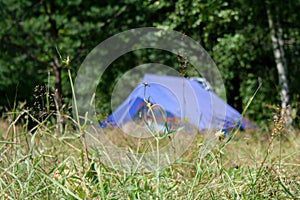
[[101, 74, 253, 130]]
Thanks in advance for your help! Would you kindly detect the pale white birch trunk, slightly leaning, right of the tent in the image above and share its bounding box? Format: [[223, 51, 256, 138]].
[[266, 1, 292, 128]]
